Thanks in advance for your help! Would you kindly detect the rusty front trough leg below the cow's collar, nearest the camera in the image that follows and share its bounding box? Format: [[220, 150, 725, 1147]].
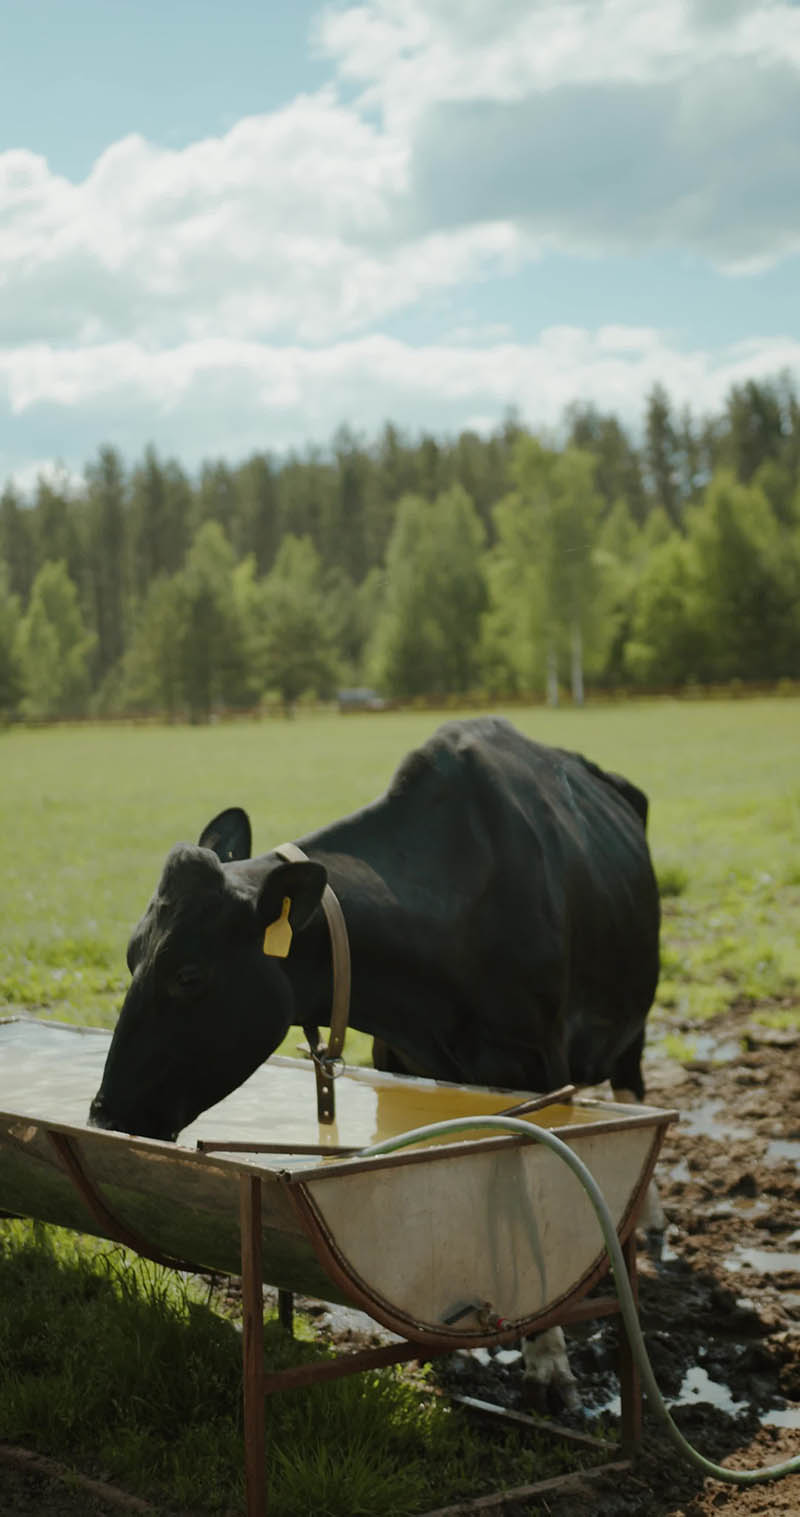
[[240, 1174, 267, 1517]]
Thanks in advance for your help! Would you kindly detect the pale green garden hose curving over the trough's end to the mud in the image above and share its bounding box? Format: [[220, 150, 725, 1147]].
[[358, 1117, 800, 1485]]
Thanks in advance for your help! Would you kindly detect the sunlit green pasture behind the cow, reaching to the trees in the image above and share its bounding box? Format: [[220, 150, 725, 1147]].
[[0, 698, 800, 1057]]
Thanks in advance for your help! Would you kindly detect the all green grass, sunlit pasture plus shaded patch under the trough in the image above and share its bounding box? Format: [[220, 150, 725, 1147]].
[[0, 699, 800, 1517]]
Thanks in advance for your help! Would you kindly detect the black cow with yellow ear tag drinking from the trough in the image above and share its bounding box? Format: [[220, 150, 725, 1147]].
[[91, 718, 659, 1139]]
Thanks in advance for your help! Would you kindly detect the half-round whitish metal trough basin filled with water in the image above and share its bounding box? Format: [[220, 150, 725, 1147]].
[[0, 1018, 676, 1347]]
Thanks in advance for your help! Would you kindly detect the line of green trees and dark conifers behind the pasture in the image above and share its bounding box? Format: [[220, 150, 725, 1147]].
[[0, 375, 800, 721]]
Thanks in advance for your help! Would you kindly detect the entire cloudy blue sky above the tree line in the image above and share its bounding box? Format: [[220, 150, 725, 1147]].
[[0, 0, 800, 490]]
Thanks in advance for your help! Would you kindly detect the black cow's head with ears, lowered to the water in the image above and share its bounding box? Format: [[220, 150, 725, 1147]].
[[90, 807, 325, 1139]]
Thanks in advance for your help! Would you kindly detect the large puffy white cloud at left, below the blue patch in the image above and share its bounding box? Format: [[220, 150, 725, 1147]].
[[0, 91, 534, 346]]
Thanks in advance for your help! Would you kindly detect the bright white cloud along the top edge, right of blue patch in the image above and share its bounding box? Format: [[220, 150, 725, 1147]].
[[317, 0, 800, 108]]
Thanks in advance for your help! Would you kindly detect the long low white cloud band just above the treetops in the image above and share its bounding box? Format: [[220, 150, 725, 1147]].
[[0, 326, 800, 475]]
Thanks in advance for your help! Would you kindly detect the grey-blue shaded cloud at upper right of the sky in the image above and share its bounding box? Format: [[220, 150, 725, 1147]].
[[411, 64, 800, 269]]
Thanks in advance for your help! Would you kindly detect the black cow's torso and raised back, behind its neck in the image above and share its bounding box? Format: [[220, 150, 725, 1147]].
[[303, 716, 659, 1083]]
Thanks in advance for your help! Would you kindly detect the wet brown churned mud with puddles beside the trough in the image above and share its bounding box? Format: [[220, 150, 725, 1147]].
[[0, 1007, 800, 1517]]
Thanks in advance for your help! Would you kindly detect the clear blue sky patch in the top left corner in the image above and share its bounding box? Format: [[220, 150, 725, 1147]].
[[0, 0, 331, 179]]
